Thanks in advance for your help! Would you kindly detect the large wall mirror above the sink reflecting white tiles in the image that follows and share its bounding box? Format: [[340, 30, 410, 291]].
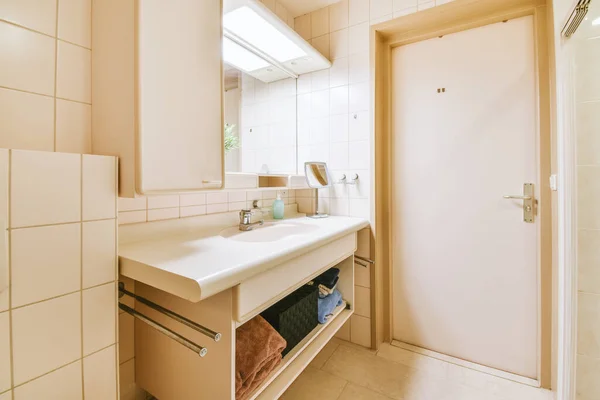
[[224, 65, 298, 175]]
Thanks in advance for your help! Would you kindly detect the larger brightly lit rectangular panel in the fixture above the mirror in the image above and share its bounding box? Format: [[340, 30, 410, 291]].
[[223, 6, 306, 62]]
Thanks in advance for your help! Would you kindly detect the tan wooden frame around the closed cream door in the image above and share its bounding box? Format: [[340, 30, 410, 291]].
[[370, 0, 556, 388]]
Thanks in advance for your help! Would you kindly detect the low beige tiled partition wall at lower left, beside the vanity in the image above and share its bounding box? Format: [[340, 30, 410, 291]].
[[0, 149, 118, 400]]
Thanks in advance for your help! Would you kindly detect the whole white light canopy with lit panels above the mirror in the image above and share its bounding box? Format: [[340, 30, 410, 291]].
[[223, 0, 331, 83]]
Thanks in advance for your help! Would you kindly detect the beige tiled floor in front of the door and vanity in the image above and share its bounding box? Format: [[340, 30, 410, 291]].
[[281, 339, 553, 400]]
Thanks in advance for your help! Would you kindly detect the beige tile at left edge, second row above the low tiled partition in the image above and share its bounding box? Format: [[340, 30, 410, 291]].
[[0, 21, 55, 96]]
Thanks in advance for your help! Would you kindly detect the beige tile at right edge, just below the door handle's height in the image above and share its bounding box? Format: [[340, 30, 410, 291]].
[[577, 230, 600, 294]]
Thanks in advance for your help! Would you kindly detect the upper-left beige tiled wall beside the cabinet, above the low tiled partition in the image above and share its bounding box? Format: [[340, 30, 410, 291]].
[[0, 0, 92, 153]]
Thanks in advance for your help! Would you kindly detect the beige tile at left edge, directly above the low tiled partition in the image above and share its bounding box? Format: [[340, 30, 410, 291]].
[[0, 89, 54, 151]]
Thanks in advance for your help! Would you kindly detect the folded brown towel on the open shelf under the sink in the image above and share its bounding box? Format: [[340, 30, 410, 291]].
[[235, 315, 287, 400]]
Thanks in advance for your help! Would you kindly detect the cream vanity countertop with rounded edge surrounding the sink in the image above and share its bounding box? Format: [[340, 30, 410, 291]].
[[119, 217, 369, 302]]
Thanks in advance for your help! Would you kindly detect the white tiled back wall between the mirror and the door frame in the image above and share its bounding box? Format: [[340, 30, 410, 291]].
[[294, 0, 451, 346]]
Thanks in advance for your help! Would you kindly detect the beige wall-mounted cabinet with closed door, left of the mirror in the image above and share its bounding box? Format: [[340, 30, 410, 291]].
[[92, 0, 224, 197]]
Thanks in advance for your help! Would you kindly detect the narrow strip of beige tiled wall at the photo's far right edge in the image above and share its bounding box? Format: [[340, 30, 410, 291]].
[[573, 7, 600, 400]]
